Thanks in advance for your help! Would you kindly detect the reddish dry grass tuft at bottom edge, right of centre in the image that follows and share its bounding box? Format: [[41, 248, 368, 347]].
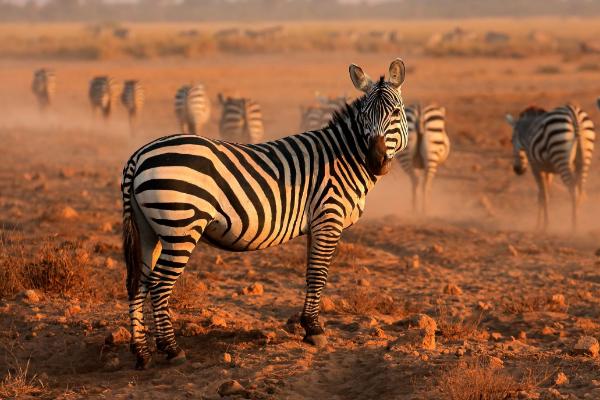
[[438, 361, 521, 400]]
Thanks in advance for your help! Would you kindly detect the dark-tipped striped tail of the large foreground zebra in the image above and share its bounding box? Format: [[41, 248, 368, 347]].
[[121, 160, 142, 300]]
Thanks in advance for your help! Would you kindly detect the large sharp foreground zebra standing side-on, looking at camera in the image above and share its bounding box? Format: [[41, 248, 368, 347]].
[[121, 59, 408, 368]]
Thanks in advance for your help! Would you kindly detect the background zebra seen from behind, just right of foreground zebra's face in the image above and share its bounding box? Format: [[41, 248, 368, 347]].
[[398, 105, 450, 213]]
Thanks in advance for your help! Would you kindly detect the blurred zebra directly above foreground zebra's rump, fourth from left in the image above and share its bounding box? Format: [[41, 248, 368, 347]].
[[175, 84, 210, 134]]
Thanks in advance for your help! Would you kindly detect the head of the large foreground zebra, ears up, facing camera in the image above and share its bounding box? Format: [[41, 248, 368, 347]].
[[350, 58, 408, 175]]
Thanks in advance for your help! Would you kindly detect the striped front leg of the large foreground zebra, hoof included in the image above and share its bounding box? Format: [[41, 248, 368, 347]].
[[300, 227, 341, 347]]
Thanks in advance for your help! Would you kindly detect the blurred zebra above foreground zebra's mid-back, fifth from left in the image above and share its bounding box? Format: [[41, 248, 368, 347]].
[[219, 93, 265, 143]]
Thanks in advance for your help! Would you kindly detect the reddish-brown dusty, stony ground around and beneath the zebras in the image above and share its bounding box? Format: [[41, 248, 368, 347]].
[[0, 47, 600, 399]]
